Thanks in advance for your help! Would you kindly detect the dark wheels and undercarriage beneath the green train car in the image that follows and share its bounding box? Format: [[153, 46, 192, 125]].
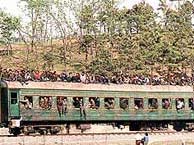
[[9, 121, 194, 135]]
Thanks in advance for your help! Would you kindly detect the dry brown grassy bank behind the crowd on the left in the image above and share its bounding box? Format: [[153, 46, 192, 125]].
[[0, 44, 85, 72]]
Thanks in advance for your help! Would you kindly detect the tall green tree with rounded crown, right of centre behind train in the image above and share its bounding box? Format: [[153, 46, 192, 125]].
[[125, 2, 160, 71]]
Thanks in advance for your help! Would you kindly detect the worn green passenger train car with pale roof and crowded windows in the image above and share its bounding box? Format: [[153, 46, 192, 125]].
[[0, 81, 194, 135]]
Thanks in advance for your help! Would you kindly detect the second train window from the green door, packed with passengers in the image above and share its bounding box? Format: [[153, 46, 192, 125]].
[[39, 96, 52, 110]]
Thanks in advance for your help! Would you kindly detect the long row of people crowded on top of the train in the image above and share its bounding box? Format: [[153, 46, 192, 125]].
[[0, 68, 194, 86]]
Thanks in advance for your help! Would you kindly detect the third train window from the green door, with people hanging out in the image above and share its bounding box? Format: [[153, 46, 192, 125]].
[[57, 96, 67, 114]]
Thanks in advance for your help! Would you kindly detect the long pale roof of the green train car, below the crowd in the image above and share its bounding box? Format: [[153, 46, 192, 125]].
[[7, 82, 193, 92]]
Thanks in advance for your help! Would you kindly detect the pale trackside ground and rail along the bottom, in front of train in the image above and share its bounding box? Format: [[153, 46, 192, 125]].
[[0, 131, 194, 145]]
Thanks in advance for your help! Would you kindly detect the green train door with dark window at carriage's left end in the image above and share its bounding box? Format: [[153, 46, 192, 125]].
[[10, 91, 19, 117]]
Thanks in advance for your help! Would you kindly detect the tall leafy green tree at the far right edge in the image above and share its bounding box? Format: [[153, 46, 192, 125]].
[[161, 1, 193, 72]]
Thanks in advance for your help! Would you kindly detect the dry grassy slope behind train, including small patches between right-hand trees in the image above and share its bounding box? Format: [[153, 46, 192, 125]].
[[0, 40, 191, 74]]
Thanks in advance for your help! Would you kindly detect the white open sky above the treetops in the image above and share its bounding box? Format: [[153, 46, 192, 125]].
[[0, 0, 185, 16]]
